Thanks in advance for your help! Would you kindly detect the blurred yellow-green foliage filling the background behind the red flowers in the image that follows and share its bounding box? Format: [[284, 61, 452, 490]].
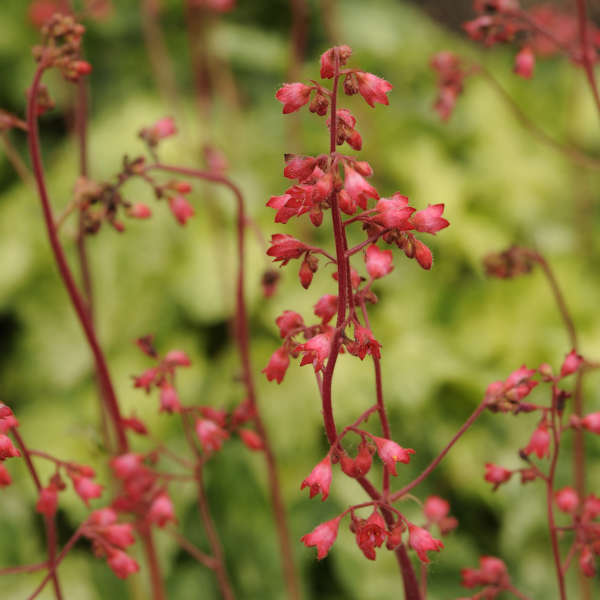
[[0, 0, 600, 600]]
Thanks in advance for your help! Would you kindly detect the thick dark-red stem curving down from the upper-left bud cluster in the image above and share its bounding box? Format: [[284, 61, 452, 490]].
[[27, 61, 165, 600]]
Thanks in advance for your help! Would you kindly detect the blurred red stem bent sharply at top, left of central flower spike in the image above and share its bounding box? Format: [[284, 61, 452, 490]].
[[148, 163, 300, 600]]
